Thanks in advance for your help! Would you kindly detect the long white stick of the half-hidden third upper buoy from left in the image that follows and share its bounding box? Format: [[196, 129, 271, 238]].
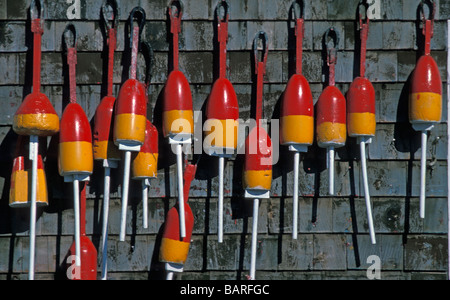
[[101, 167, 111, 280]]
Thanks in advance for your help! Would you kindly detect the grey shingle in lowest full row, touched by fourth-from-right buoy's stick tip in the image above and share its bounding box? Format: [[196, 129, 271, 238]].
[[278, 234, 314, 271]]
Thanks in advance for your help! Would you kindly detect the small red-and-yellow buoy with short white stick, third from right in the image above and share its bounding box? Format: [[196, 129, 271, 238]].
[[316, 27, 347, 195]]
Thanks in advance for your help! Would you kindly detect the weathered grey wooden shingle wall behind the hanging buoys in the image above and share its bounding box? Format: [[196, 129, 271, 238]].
[[0, 0, 450, 279]]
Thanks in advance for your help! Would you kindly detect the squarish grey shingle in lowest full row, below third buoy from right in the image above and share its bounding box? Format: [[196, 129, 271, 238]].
[[313, 234, 347, 271]]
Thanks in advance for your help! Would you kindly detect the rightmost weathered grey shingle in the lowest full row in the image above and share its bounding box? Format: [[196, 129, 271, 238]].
[[405, 235, 447, 271]]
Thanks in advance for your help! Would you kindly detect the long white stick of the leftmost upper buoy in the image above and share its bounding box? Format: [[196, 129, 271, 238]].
[[28, 135, 39, 280]]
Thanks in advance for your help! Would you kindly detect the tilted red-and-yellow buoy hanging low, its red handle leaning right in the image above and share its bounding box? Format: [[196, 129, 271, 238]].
[[159, 164, 197, 280]]
